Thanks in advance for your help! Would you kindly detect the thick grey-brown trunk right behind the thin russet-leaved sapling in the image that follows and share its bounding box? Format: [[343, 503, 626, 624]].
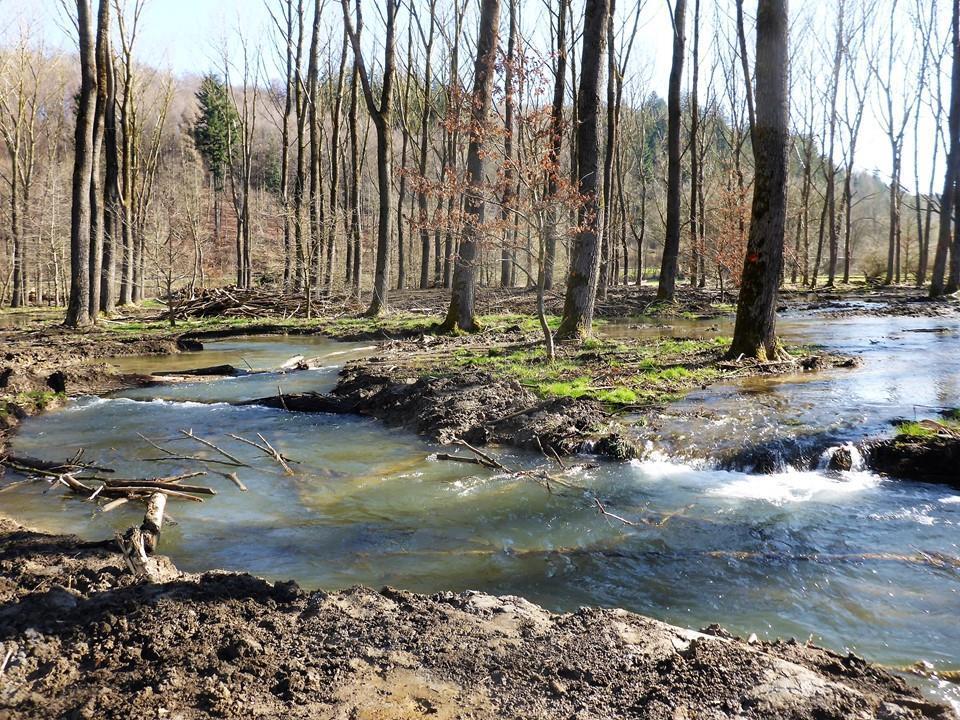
[[557, 0, 608, 338]]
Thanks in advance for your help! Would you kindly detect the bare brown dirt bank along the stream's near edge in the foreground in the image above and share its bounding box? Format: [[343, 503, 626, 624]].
[[0, 518, 956, 720]]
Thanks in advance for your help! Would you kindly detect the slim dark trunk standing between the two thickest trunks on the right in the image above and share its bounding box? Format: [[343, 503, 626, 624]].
[[657, 0, 687, 301]]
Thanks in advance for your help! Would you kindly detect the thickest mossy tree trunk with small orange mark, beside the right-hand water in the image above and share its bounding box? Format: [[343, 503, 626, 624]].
[[728, 0, 790, 360]]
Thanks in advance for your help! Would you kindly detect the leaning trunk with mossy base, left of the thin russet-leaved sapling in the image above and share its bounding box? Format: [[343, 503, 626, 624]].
[[441, 0, 500, 332]]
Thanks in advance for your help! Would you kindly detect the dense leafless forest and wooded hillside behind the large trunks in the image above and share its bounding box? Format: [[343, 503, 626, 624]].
[[0, 0, 956, 334]]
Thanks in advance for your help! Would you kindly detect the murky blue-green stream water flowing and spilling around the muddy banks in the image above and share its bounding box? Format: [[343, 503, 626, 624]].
[[0, 313, 960, 706]]
